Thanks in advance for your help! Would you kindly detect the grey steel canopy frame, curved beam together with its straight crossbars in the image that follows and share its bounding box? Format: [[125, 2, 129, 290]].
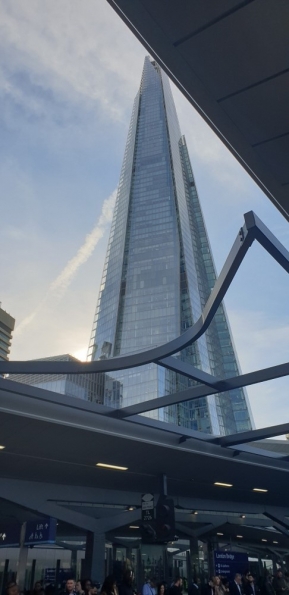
[[0, 211, 289, 460]]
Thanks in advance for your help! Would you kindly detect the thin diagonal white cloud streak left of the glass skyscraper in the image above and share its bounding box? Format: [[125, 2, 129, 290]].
[[15, 190, 117, 336]]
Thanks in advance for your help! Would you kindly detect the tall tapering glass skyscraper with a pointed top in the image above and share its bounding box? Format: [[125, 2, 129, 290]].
[[89, 57, 252, 434]]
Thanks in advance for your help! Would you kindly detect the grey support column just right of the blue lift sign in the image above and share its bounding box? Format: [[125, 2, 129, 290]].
[[83, 531, 105, 585]]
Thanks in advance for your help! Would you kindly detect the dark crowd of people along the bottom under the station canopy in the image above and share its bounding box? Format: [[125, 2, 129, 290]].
[[6, 569, 289, 595]]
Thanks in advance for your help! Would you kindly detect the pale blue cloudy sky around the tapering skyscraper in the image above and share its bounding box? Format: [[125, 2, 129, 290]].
[[0, 0, 289, 434]]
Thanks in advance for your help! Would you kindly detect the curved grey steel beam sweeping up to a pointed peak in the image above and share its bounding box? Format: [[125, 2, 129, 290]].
[[0, 211, 289, 380]]
